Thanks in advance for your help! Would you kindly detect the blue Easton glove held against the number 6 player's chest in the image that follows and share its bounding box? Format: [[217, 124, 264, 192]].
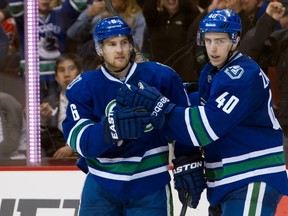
[[103, 107, 151, 143]]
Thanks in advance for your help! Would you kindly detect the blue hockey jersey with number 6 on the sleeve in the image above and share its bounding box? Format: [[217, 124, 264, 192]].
[[63, 62, 195, 198]]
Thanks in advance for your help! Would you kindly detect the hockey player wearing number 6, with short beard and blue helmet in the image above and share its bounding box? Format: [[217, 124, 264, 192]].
[[62, 17, 206, 216]]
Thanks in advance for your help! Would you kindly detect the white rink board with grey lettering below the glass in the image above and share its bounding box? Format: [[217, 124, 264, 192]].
[[0, 170, 208, 216]]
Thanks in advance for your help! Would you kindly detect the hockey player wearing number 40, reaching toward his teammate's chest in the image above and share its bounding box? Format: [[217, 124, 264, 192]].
[[116, 7, 288, 216]]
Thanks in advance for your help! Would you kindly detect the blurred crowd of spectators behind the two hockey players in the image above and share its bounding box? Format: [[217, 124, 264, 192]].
[[0, 0, 288, 160]]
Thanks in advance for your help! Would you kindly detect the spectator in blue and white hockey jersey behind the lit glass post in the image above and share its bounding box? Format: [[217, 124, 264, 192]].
[[9, 0, 86, 100]]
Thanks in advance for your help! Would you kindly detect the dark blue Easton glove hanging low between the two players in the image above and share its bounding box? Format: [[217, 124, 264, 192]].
[[172, 152, 206, 208]]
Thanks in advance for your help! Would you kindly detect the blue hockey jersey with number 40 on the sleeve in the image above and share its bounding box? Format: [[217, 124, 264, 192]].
[[167, 53, 288, 205]]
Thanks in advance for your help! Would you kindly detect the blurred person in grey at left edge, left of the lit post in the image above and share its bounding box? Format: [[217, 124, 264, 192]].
[[0, 92, 27, 160]]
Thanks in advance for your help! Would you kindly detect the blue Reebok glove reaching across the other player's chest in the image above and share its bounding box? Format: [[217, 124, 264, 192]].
[[116, 81, 175, 128]]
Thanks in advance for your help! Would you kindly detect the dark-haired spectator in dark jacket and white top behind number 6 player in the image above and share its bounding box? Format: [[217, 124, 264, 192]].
[[40, 53, 82, 158]]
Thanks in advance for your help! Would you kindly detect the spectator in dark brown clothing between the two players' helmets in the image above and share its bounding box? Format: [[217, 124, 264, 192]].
[[143, 0, 200, 82]]
